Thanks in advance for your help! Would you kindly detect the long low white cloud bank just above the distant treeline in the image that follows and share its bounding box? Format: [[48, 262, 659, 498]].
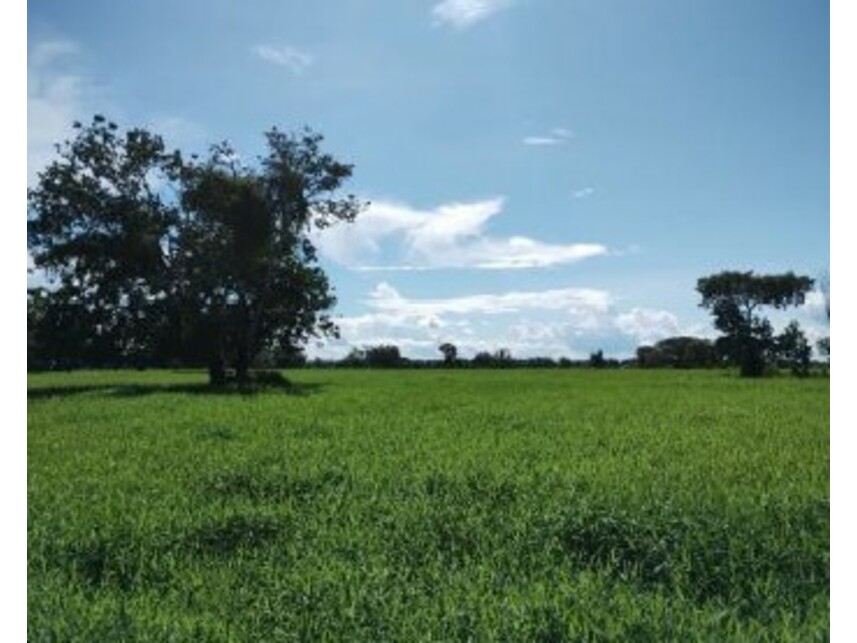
[[309, 282, 697, 359]]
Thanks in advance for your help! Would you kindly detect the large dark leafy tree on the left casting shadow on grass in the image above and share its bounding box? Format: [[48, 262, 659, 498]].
[[28, 116, 360, 383]]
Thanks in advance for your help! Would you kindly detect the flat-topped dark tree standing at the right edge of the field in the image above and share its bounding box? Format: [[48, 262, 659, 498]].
[[696, 271, 813, 377]]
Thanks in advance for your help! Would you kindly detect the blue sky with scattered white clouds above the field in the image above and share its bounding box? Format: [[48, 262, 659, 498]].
[[27, 0, 830, 357]]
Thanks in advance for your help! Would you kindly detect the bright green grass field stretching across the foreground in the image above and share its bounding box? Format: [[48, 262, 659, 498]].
[[27, 370, 830, 642]]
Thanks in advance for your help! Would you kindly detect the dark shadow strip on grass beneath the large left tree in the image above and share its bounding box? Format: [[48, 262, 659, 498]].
[[27, 378, 327, 400]]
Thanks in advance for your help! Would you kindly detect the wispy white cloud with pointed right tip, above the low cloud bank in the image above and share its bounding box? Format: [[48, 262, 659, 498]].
[[317, 197, 608, 271]]
